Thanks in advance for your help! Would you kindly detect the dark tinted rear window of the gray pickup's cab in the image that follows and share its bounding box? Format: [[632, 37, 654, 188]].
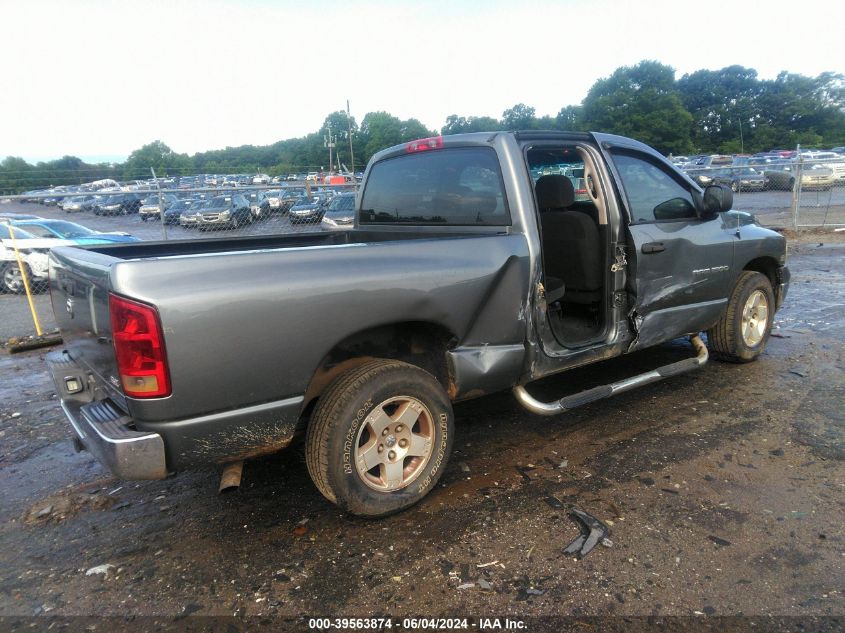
[[360, 147, 510, 226]]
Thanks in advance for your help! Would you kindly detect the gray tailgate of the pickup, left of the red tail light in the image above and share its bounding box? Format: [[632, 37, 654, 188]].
[[50, 247, 125, 405]]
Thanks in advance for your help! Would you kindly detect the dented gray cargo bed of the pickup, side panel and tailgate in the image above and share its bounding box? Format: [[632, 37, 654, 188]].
[[50, 227, 529, 465]]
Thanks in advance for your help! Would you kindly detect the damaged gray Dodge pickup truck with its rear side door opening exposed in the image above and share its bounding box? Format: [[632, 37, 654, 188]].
[[49, 131, 789, 516]]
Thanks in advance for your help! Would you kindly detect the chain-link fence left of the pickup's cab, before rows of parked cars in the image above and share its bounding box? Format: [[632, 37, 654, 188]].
[[0, 175, 357, 341]]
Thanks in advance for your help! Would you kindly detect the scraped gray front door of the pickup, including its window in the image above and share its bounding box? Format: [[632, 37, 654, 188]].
[[597, 135, 735, 349]]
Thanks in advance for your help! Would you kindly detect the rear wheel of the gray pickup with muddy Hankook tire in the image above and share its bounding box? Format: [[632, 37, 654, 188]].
[[305, 360, 454, 517]]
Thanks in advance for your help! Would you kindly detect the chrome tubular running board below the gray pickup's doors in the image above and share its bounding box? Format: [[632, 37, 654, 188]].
[[513, 334, 709, 415]]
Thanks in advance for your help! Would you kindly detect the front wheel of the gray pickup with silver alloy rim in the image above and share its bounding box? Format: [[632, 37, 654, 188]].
[[707, 270, 775, 363]]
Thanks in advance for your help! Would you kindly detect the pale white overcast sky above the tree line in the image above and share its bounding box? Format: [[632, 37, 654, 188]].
[[0, 0, 845, 162]]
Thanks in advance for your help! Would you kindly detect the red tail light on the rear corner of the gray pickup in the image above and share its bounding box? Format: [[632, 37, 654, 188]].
[[109, 295, 170, 398]]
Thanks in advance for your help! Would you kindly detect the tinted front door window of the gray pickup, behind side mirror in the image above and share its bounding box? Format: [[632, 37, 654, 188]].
[[613, 153, 696, 223]]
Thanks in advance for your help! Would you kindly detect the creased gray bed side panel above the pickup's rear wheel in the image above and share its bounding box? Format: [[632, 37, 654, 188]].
[[117, 231, 528, 457]]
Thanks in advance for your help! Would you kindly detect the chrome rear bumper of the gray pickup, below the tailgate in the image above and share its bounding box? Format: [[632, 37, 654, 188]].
[[47, 350, 167, 479]]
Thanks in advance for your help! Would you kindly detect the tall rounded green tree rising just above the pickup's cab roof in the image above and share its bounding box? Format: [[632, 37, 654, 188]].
[[584, 61, 693, 154]]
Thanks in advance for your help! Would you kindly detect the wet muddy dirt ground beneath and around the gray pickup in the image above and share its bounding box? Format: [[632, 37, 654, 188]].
[[0, 234, 845, 630]]
